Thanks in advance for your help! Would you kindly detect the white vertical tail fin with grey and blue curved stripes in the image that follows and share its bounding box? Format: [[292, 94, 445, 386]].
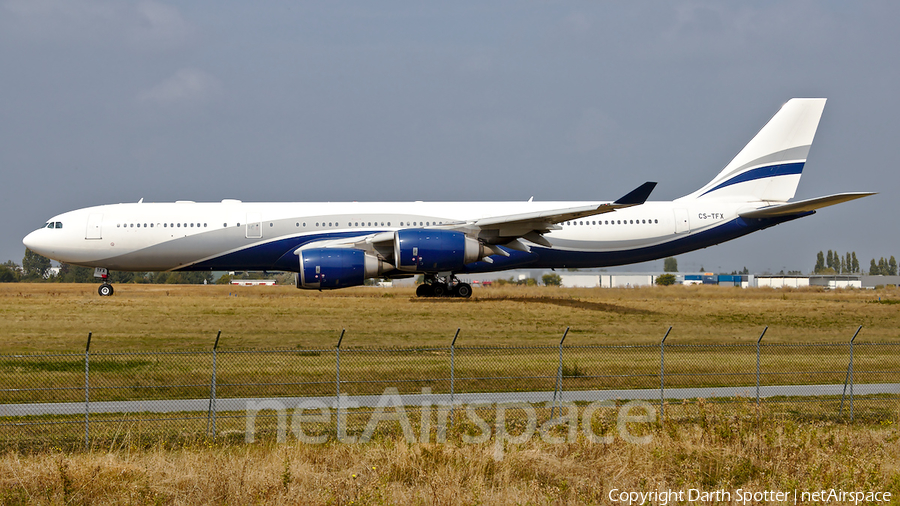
[[679, 98, 825, 202]]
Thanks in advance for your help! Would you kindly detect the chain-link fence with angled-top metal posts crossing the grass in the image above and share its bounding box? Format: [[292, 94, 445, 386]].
[[0, 329, 900, 446]]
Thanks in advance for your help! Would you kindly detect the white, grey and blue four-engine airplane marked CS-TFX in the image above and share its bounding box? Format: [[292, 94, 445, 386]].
[[23, 98, 874, 298]]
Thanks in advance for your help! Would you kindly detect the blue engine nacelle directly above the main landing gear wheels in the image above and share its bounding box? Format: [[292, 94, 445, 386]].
[[394, 228, 485, 272]]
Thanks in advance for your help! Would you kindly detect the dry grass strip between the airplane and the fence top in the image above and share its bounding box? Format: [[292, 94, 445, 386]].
[[0, 284, 900, 353]]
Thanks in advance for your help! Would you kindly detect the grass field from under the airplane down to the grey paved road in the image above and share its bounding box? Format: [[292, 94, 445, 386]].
[[0, 284, 900, 403]]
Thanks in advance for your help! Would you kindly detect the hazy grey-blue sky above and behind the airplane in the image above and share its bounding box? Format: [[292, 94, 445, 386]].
[[0, 0, 900, 272]]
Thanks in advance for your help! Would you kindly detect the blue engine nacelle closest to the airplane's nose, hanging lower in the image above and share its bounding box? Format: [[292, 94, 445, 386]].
[[297, 248, 394, 290]]
